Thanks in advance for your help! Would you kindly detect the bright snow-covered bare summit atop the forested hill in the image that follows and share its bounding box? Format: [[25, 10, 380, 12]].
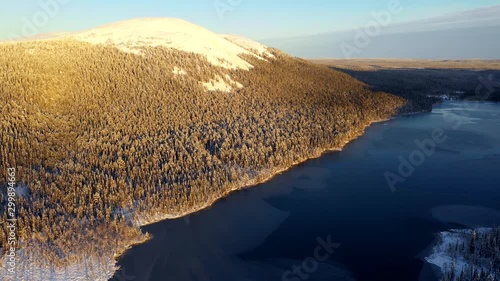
[[66, 18, 272, 70]]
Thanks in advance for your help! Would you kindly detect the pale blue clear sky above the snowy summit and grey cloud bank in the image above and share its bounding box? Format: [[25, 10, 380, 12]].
[[0, 0, 500, 40]]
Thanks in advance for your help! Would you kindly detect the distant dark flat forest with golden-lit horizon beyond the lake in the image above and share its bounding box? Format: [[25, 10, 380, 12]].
[[312, 59, 500, 107]]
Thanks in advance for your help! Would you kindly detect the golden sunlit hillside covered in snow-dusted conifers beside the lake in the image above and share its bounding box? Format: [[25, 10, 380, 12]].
[[0, 40, 405, 266]]
